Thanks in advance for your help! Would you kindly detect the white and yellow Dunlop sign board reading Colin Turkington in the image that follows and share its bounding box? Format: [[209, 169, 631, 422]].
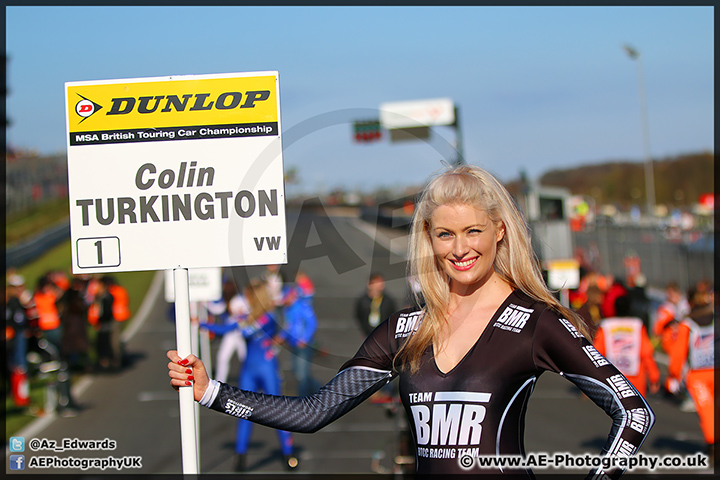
[[65, 72, 287, 273]]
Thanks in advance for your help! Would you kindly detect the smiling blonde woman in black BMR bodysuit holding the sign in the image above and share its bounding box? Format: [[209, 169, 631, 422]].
[[168, 166, 654, 478]]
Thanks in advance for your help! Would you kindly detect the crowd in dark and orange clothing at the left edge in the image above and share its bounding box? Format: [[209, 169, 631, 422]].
[[5, 270, 131, 416]]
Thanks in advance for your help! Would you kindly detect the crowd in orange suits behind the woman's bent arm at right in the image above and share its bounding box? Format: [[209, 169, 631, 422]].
[[570, 271, 717, 456]]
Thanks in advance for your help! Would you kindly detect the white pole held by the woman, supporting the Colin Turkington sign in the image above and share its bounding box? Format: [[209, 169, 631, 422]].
[[173, 268, 198, 475]]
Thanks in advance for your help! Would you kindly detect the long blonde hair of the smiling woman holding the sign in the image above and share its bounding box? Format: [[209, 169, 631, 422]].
[[395, 165, 589, 372]]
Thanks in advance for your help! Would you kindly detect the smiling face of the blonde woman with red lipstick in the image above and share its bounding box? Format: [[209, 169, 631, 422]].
[[430, 204, 505, 291]]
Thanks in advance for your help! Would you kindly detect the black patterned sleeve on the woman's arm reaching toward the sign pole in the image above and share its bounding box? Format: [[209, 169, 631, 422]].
[[210, 321, 394, 433]]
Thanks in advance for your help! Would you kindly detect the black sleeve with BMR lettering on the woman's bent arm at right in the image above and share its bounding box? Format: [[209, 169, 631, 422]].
[[533, 310, 655, 478]]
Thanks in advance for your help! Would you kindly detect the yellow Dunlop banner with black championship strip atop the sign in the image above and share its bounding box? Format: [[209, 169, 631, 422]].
[[66, 75, 279, 146]]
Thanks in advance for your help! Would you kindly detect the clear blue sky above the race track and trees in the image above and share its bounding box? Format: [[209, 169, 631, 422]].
[[6, 6, 714, 191]]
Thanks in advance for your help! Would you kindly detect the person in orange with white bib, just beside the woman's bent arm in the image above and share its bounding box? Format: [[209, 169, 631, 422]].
[[593, 295, 660, 396]]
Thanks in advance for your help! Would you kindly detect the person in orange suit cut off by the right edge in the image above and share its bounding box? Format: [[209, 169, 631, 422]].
[[668, 289, 717, 457]]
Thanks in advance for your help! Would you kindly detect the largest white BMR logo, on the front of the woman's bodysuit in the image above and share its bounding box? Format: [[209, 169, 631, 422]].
[[410, 392, 491, 447]]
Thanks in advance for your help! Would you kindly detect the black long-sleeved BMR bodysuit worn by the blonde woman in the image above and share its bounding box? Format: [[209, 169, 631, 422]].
[[201, 291, 654, 477]]
